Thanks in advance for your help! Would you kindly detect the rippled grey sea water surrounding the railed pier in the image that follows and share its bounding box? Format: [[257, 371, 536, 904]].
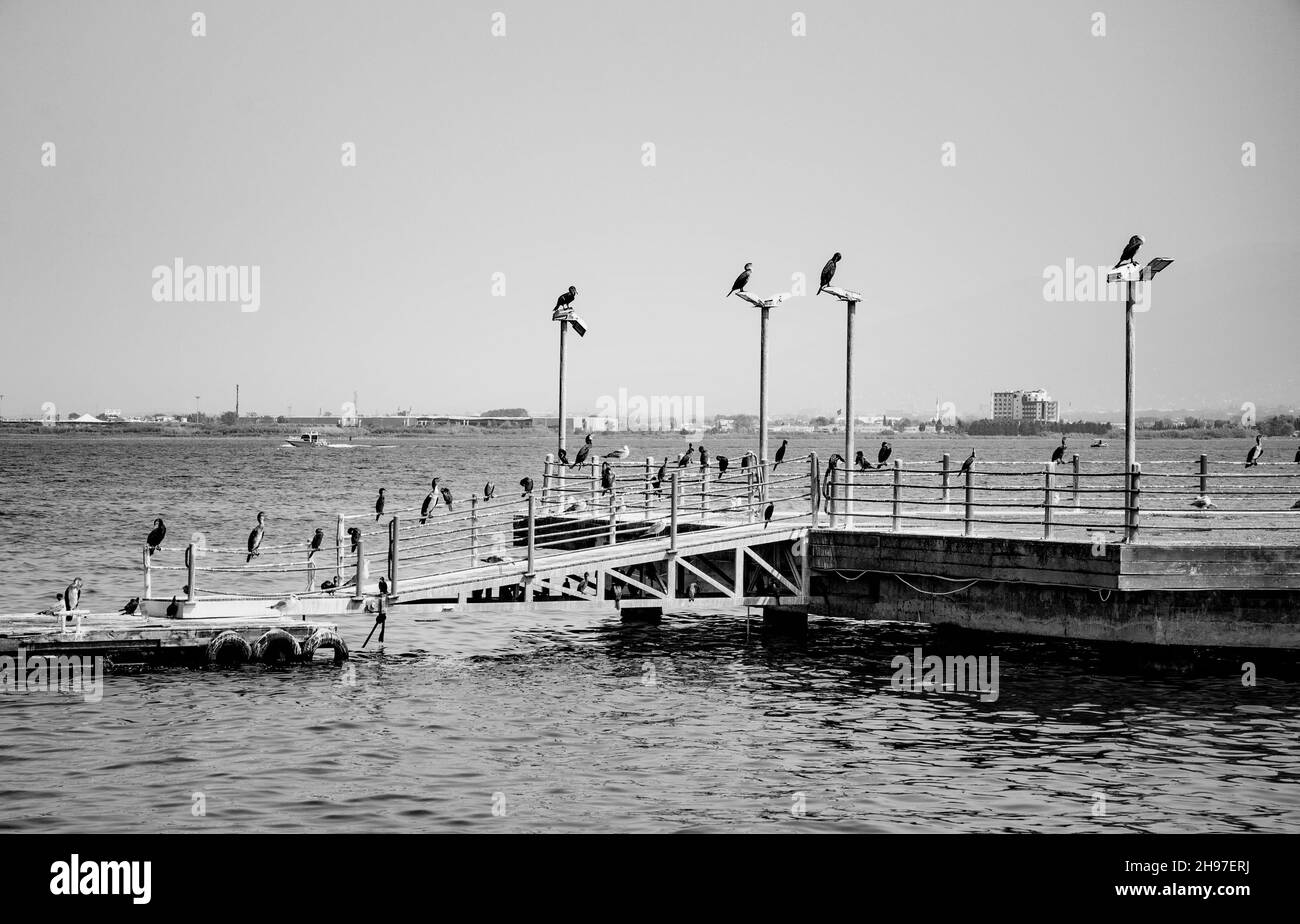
[[0, 434, 1300, 832]]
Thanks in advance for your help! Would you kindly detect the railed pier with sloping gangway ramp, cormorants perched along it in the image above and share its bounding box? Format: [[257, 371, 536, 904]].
[[111, 455, 1300, 648]]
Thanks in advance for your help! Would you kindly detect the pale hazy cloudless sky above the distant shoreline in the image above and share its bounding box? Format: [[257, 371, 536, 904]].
[[0, 0, 1300, 417]]
